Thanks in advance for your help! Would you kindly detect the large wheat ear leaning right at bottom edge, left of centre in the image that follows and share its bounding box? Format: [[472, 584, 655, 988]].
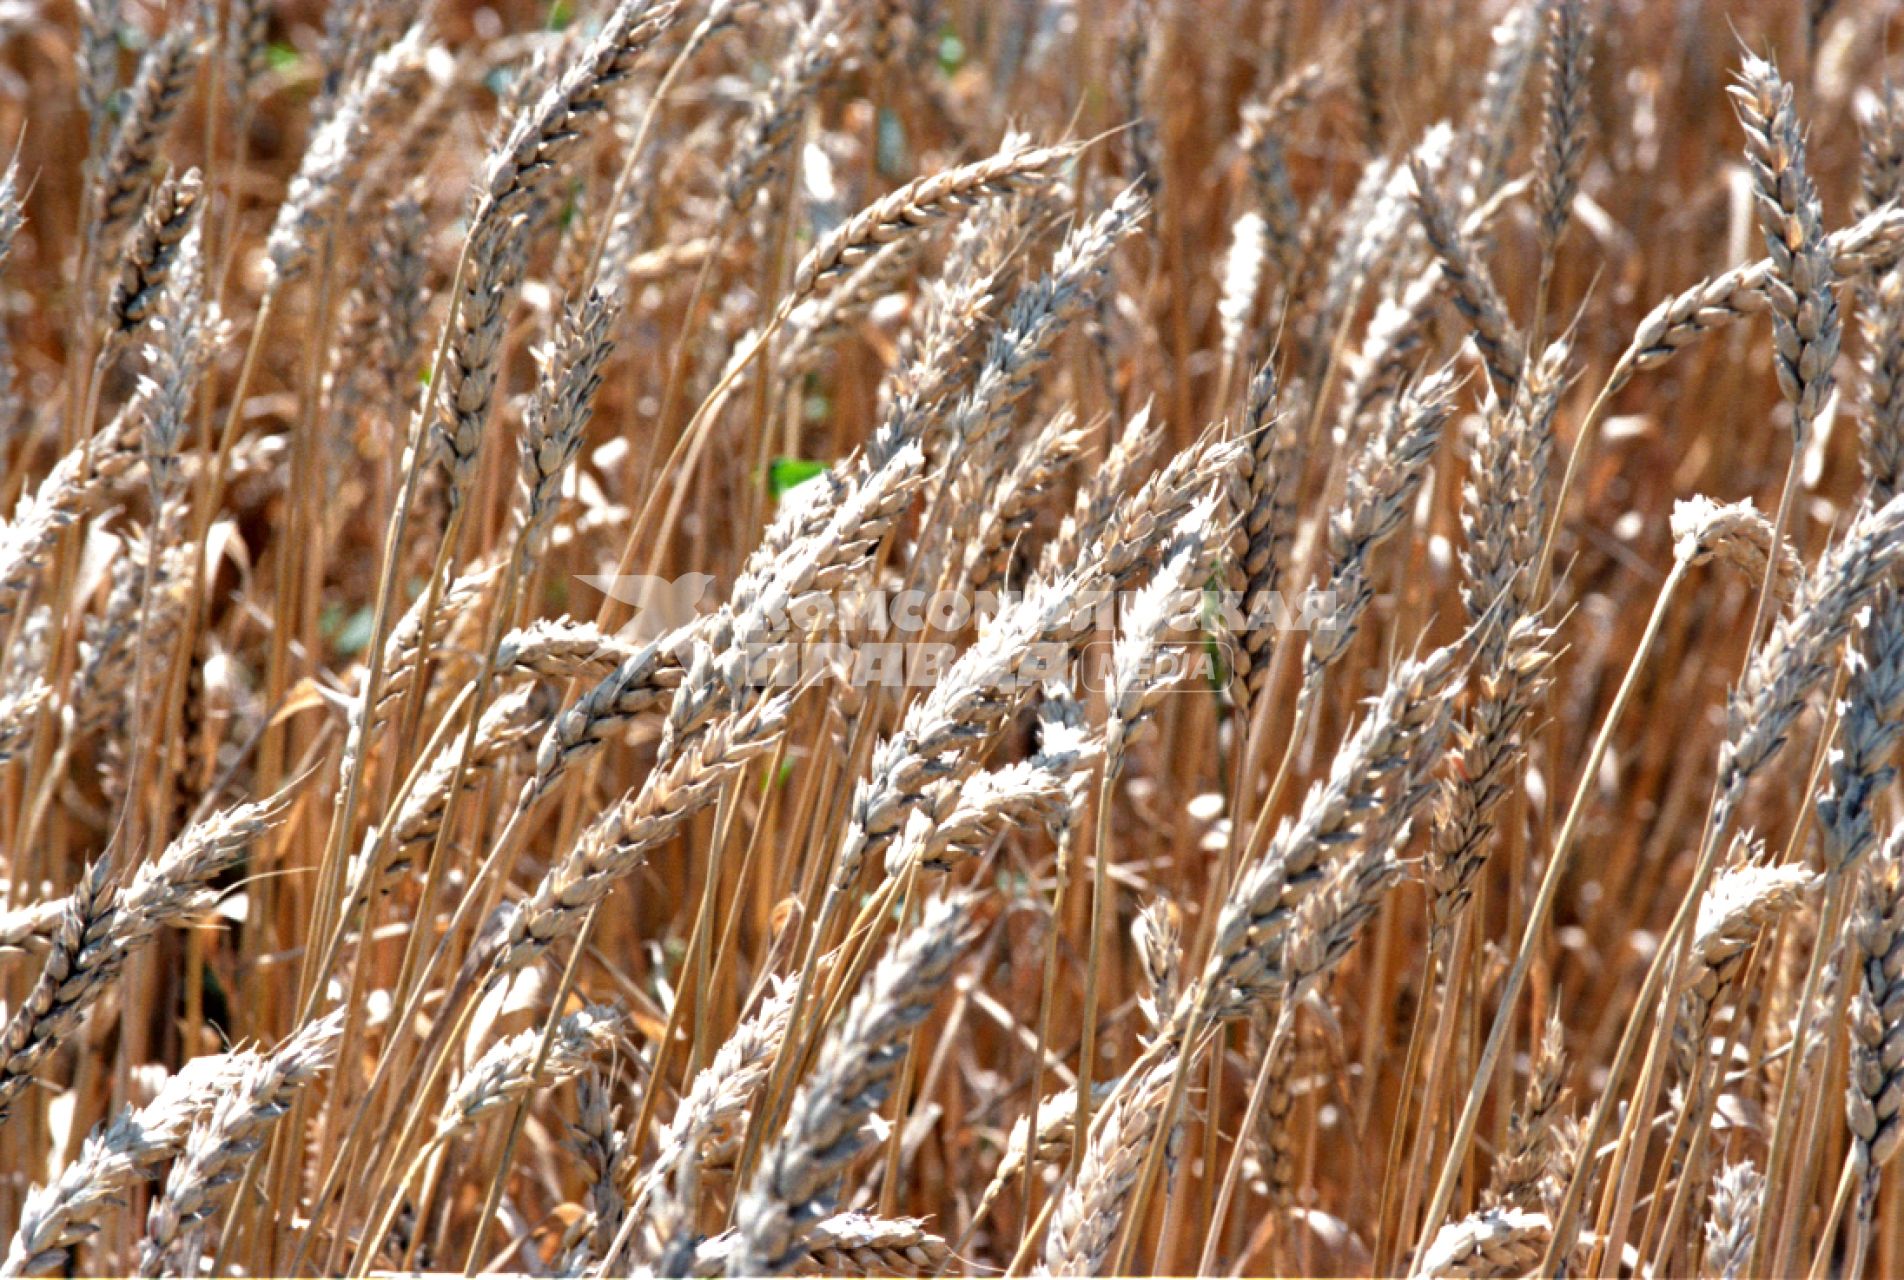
[[727, 899, 967, 1276]]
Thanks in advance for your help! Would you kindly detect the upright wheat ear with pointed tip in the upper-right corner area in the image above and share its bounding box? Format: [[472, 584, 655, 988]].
[[1729, 53, 1839, 442]]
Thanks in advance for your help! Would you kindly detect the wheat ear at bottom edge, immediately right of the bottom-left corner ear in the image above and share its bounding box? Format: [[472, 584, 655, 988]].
[[139, 1010, 345, 1276]]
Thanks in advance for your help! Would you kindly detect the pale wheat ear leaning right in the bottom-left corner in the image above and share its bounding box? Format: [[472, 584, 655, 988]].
[[0, 1053, 261, 1276]]
